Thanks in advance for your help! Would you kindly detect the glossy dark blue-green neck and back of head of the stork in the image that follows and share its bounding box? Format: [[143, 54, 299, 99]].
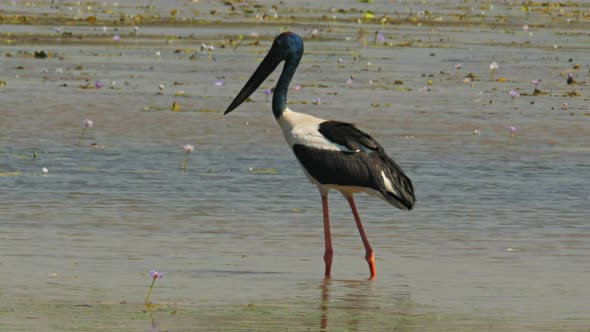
[[272, 34, 303, 119]]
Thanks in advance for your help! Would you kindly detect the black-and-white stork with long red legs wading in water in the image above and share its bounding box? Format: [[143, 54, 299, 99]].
[[224, 32, 416, 279]]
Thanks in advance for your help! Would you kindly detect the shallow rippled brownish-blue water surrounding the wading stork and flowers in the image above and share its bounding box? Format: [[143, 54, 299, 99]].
[[0, 2, 590, 331]]
